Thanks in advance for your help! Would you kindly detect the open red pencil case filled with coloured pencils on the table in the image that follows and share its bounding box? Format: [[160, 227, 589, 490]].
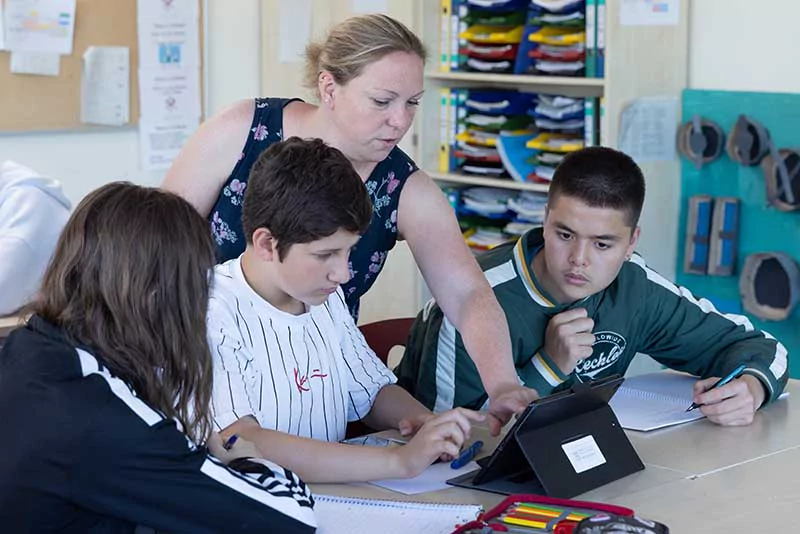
[[452, 493, 633, 534]]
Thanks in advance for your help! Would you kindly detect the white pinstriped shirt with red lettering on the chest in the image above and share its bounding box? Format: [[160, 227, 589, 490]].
[[207, 258, 396, 441]]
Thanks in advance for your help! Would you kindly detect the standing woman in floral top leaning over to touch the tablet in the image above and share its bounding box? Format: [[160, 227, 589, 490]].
[[163, 14, 536, 433]]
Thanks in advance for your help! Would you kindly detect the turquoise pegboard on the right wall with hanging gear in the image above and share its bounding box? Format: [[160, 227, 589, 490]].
[[676, 89, 800, 378]]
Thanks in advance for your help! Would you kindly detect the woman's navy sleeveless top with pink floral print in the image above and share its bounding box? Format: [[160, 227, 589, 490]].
[[209, 98, 417, 319]]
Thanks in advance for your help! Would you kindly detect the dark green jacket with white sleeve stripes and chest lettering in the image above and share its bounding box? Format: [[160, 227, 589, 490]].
[[394, 228, 788, 412]]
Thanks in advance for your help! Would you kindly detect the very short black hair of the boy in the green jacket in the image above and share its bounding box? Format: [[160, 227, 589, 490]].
[[548, 146, 645, 228]]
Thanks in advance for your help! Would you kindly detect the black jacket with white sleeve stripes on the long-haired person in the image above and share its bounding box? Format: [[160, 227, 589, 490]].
[[0, 316, 316, 532]]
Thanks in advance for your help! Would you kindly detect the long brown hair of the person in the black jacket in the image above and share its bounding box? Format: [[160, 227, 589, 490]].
[[28, 182, 215, 444]]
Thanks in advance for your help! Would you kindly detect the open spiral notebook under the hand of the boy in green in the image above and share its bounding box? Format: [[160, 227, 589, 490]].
[[609, 371, 703, 431]]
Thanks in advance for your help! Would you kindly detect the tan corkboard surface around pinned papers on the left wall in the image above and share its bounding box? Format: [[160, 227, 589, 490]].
[[0, 0, 203, 132]]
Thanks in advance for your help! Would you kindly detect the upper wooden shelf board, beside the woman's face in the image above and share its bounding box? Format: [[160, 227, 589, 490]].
[[425, 71, 605, 96]]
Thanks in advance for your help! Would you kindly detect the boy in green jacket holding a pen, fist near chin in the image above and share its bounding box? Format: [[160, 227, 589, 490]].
[[395, 147, 788, 425]]
